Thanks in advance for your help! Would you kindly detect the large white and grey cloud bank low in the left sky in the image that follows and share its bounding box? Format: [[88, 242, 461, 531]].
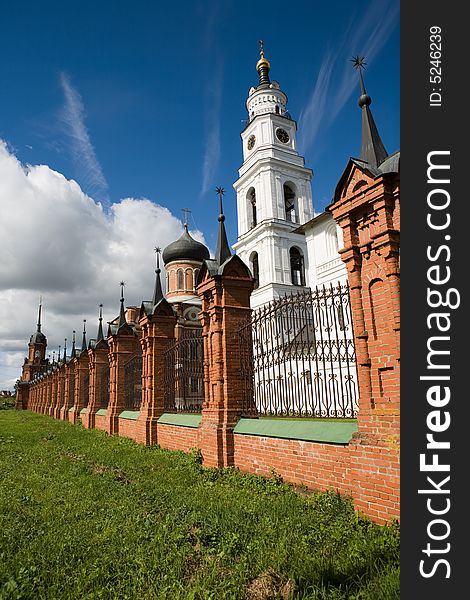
[[0, 140, 204, 389]]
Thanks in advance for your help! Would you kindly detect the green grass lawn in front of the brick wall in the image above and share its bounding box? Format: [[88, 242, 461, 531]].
[[0, 410, 399, 600]]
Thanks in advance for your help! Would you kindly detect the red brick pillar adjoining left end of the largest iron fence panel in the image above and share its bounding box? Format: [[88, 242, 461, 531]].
[[197, 256, 253, 467]]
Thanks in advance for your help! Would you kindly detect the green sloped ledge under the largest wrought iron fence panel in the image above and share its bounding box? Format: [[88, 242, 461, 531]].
[[233, 419, 357, 444]]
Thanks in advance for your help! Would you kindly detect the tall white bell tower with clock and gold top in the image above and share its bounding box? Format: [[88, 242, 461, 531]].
[[233, 42, 314, 308]]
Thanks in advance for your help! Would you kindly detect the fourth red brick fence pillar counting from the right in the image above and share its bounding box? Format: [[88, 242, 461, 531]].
[[106, 324, 140, 434]]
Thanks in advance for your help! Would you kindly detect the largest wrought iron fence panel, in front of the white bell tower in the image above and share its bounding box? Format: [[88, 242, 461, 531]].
[[237, 284, 358, 418]]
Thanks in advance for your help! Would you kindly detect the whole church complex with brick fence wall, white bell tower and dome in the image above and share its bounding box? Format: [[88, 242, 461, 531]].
[[16, 45, 400, 523]]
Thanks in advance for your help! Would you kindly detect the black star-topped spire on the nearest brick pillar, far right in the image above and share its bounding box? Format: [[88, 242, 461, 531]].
[[351, 56, 388, 168]]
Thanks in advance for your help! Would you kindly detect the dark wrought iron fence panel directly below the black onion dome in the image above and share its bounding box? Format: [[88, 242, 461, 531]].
[[164, 329, 204, 413]]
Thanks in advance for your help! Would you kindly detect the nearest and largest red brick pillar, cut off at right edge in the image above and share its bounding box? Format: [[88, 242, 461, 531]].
[[328, 161, 400, 521]]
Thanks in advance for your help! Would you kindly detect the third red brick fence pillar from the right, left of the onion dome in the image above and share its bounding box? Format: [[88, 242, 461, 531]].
[[136, 299, 177, 445]]
